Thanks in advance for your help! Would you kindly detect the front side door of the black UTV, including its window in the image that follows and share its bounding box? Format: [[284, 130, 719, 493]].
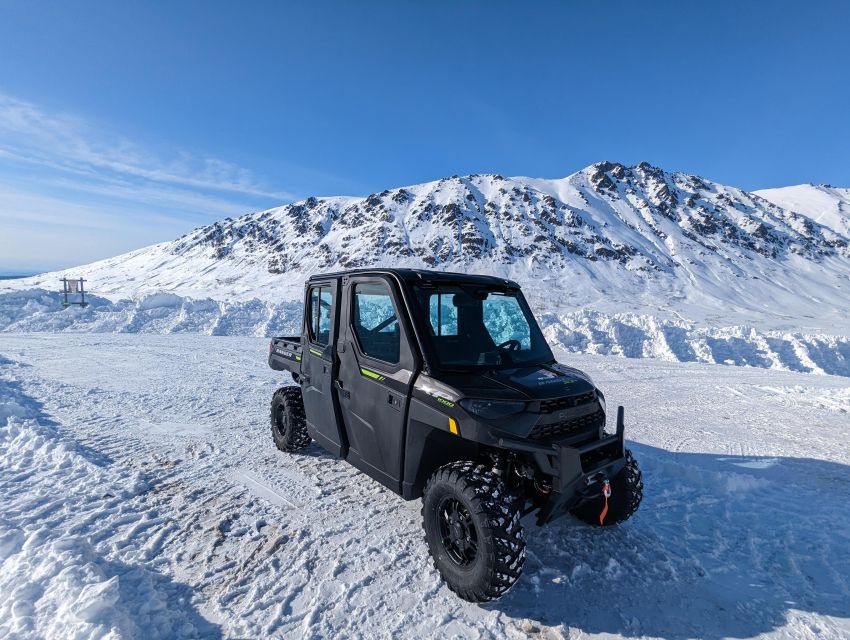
[[338, 277, 416, 493]]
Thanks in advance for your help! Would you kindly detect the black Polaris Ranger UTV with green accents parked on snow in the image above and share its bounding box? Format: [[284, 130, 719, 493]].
[[269, 269, 643, 602]]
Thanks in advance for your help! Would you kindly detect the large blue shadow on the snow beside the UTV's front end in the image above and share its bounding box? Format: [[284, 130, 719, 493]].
[[484, 444, 850, 640]]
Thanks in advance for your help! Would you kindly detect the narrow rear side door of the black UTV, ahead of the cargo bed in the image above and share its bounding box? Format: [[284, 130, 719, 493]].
[[301, 280, 346, 457]]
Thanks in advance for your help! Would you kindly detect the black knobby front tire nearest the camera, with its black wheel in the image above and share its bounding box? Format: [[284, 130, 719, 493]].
[[422, 462, 525, 602]]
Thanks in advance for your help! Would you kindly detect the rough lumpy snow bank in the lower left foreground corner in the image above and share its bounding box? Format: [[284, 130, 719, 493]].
[[0, 362, 212, 638]]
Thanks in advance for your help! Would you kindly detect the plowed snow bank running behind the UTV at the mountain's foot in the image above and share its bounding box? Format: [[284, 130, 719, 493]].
[[0, 289, 850, 376]]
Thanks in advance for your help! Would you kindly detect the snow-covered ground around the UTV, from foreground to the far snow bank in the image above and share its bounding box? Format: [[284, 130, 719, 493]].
[[0, 333, 850, 639]]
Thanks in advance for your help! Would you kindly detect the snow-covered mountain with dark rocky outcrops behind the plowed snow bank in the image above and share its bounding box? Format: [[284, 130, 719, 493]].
[[9, 162, 850, 333]]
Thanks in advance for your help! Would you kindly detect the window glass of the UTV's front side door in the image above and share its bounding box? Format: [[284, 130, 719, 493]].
[[352, 284, 401, 364]]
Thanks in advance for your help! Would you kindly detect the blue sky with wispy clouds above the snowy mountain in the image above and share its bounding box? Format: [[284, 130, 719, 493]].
[[0, 1, 850, 273]]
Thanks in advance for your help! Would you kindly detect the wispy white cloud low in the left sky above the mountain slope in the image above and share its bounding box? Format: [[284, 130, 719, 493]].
[[0, 93, 296, 271]]
